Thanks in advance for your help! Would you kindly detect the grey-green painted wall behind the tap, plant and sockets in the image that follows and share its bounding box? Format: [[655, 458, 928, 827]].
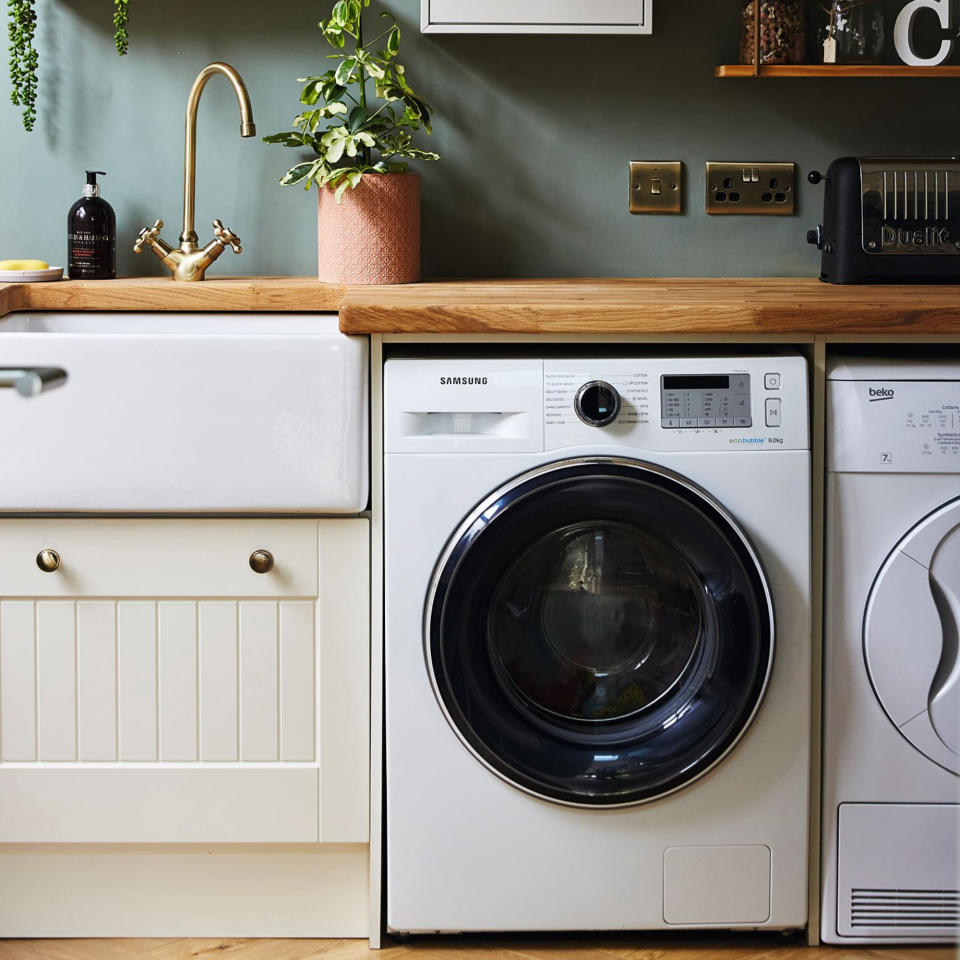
[[0, 0, 960, 276]]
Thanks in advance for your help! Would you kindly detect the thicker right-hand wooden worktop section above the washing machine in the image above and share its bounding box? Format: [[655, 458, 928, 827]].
[[340, 278, 960, 334]]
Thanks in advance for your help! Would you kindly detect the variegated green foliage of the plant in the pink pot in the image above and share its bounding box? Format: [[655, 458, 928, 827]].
[[263, 0, 440, 202]]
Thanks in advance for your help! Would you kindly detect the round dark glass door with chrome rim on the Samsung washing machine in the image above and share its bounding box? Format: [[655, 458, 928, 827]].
[[425, 458, 773, 807]]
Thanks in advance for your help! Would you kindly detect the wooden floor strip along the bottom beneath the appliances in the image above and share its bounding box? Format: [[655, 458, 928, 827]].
[[0, 934, 960, 960]]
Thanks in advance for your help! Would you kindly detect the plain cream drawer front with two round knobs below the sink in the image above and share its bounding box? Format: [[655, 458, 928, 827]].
[[0, 519, 317, 597]]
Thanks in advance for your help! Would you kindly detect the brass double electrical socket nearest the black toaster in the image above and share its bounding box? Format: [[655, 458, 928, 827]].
[[707, 161, 797, 217]]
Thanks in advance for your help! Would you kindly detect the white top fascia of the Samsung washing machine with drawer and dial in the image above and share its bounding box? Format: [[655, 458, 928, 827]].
[[384, 354, 810, 453]]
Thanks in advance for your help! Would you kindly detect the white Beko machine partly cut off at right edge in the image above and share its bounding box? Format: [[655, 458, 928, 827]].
[[821, 358, 960, 943]]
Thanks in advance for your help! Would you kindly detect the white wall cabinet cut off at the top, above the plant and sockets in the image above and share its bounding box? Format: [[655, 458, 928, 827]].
[[421, 0, 653, 33]]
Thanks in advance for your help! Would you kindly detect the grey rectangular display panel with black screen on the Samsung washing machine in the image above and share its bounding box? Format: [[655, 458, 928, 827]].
[[660, 373, 753, 430]]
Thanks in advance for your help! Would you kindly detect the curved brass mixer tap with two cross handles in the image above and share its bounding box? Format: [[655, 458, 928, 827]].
[[133, 63, 257, 280]]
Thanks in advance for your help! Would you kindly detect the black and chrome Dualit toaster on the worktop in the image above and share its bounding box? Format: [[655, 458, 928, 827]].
[[807, 157, 960, 283]]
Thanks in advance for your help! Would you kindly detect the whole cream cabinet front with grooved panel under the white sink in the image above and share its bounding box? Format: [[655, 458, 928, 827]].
[[0, 519, 369, 843]]
